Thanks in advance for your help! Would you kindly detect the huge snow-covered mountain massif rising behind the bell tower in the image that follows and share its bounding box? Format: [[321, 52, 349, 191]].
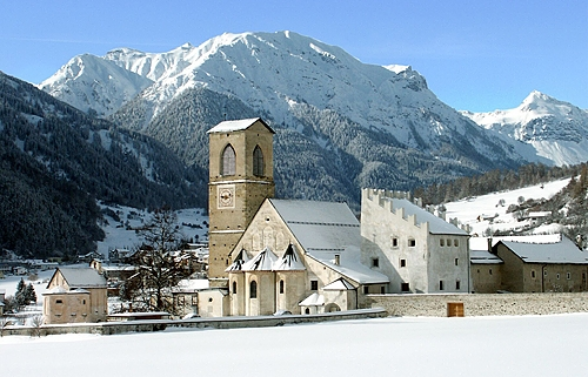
[[41, 31, 537, 202]]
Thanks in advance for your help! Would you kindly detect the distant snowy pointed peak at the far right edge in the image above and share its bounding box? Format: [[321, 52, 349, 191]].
[[462, 91, 588, 166]]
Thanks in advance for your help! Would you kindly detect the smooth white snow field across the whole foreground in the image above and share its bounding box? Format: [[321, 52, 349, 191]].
[[0, 314, 588, 377]]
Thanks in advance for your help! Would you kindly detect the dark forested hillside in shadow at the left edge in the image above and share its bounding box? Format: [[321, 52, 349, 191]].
[[0, 73, 206, 257]]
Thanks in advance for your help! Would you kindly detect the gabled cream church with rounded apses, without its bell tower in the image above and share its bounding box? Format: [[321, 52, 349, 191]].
[[227, 199, 388, 315]]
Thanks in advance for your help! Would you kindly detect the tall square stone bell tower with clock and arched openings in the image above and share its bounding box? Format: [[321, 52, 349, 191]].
[[208, 118, 275, 288]]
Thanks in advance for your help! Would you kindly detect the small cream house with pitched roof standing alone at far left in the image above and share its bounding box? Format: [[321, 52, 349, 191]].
[[43, 268, 108, 324]]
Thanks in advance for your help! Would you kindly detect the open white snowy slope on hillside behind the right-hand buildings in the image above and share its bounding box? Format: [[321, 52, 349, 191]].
[[445, 178, 570, 236]]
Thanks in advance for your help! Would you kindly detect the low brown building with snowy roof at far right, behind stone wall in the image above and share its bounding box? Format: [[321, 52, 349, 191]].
[[493, 235, 588, 292]]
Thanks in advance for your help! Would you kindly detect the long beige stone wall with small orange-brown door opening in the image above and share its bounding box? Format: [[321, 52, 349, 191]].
[[364, 292, 588, 317]]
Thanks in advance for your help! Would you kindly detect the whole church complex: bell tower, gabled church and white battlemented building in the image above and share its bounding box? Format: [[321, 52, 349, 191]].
[[204, 118, 470, 317]]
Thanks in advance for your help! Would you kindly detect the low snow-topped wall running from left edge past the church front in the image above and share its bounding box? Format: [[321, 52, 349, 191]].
[[0, 308, 388, 336]]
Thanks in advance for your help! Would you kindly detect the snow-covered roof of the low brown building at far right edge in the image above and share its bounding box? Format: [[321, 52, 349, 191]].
[[500, 236, 588, 264]]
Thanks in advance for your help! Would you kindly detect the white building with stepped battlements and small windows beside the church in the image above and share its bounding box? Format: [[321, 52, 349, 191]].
[[361, 189, 471, 293]]
